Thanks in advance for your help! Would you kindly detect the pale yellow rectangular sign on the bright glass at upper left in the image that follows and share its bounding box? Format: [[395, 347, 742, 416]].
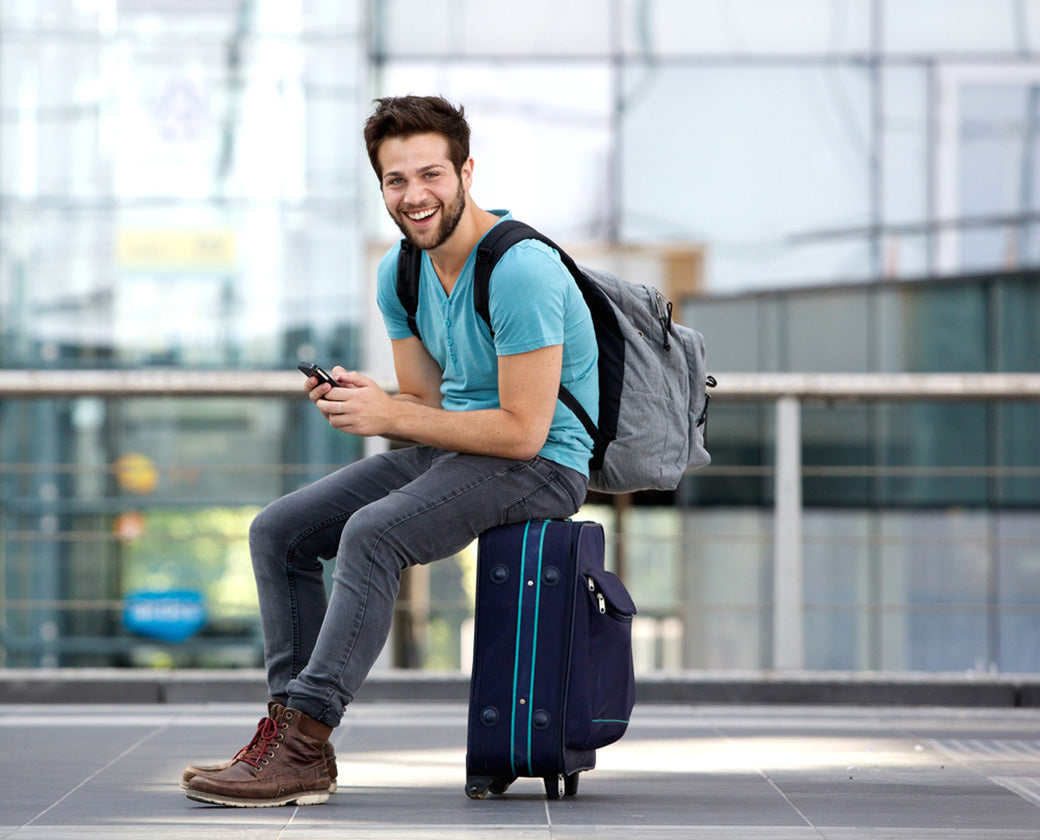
[[115, 228, 238, 270]]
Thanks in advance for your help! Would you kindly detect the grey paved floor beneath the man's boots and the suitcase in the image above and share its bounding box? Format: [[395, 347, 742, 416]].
[[0, 702, 1040, 840]]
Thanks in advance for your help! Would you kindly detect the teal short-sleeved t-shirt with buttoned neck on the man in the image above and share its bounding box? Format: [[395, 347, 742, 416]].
[[376, 210, 599, 476]]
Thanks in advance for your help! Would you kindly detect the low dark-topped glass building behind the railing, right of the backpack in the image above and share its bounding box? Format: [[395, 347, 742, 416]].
[[679, 271, 1040, 672]]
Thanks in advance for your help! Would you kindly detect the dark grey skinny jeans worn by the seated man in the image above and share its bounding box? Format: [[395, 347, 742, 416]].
[[250, 446, 587, 727]]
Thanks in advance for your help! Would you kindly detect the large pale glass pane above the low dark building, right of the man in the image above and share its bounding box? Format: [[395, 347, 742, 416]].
[[621, 65, 870, 291]]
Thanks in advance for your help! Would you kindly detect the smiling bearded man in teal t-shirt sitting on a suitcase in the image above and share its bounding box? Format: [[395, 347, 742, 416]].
[[182, 97, 598, 807]]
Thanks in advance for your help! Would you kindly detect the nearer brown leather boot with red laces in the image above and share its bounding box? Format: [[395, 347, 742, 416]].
[[187, 708, 332, 808]]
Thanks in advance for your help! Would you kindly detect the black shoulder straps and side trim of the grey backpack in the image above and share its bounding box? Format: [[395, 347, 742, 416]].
[[397, 219, 625, 470]]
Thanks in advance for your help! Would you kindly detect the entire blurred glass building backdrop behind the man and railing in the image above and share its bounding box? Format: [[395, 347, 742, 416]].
[[0, 0, 1040, 672]]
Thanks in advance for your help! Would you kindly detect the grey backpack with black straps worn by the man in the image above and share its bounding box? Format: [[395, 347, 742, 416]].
[[397, 220, 716, 493]]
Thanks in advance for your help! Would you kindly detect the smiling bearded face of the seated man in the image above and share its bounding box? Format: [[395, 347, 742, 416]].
[[379, 134, 472, 251]]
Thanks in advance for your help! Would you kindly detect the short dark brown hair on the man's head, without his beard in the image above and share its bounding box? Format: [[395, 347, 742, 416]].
[[365, 96, 469, 180]]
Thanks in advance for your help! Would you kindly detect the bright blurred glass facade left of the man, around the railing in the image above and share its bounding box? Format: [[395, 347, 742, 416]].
[[0, 0, 369, 665]]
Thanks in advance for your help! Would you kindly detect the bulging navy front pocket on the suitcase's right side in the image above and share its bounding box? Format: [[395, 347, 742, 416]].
[[567, 571, 635, 750]]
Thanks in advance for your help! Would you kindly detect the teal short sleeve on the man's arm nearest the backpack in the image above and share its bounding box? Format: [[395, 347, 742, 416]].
[[489, 240, 576, 356]]
